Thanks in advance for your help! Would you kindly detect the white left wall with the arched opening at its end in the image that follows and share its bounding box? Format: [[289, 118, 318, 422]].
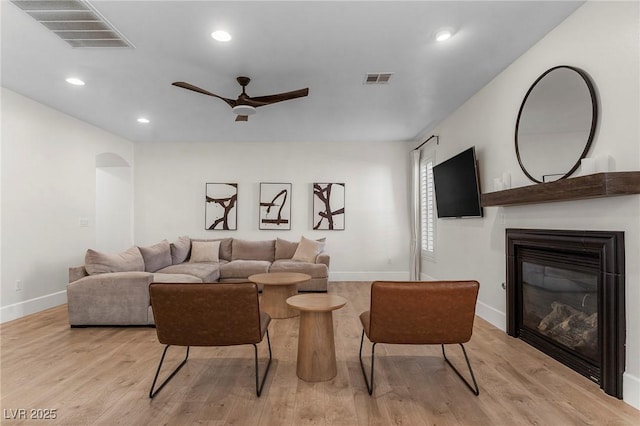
[[0, 89, 133, 321]]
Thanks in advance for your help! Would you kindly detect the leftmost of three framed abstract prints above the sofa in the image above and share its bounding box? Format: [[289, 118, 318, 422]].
[[204, 183, 238, 231]]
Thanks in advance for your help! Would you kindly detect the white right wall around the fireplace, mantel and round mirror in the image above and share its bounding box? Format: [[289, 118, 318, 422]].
[[423, 2, 640, 408]]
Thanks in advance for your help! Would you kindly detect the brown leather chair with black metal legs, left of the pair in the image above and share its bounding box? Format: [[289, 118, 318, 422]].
[[149, 283, 271, 398]]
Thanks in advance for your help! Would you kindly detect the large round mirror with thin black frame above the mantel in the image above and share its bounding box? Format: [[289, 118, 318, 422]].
[[515, 65, 598, 183]]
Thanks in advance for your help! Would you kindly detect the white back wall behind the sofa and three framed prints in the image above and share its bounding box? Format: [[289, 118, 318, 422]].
[[134, 140, 409, 280]]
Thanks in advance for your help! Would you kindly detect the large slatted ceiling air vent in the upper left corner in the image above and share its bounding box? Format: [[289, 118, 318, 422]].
[[11, 0, 134, 47]]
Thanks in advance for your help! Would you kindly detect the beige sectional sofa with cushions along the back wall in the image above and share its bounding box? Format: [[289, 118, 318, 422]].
[[67, 237, 330, 327]]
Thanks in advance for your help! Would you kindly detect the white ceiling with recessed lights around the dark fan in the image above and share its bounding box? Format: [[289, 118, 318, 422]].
[[1, 0, 582, 142]]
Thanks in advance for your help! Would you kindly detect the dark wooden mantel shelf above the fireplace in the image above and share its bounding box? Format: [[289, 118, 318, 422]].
[[481, 172, 640, 207]]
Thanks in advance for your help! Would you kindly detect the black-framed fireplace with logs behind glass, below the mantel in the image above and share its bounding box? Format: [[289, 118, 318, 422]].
[[506, 229, 625, 399]]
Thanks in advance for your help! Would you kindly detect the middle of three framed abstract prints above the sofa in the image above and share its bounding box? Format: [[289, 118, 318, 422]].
[[259, 182, 291, 230]]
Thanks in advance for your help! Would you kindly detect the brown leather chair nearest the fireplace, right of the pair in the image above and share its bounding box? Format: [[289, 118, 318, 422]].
[[359, 281, 480, 395]]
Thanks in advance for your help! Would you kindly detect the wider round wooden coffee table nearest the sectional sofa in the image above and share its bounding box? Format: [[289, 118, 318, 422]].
[[249, 272, 311, 318]]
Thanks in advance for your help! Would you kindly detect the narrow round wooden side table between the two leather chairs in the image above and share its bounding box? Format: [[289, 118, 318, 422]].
[[287, 293, 347, 382]]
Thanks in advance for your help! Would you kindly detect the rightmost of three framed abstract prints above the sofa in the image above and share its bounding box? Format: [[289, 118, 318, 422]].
[[313, 183, 345, 231]]
